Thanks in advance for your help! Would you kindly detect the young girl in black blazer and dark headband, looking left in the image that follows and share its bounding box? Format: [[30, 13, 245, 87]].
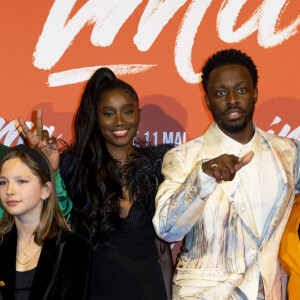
[[0, 145, 92, 300]]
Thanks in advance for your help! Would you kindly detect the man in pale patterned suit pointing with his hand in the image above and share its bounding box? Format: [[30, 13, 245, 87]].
[[153, 49, 300, 300]]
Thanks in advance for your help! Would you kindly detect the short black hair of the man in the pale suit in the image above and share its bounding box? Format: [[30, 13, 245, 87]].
[[202, 49, 258, 93]]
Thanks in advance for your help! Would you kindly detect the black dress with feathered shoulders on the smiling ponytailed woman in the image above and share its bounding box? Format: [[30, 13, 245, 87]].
[[60, 145, 172, 300]]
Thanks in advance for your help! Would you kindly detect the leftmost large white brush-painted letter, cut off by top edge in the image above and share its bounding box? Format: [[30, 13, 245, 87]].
[[33, 0, 142, 70]]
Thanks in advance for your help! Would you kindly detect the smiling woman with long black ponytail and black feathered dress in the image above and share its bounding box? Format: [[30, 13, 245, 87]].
[[60, 68, 173, 300]]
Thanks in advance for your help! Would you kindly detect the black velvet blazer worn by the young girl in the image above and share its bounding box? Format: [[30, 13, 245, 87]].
[[0, 228, 92, 300]]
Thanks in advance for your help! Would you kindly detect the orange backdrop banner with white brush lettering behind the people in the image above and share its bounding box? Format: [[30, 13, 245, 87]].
[[0, 0, 300, 145]]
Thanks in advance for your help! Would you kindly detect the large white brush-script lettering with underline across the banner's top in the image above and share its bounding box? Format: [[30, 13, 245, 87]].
[[33, 0, 300, 86]]
